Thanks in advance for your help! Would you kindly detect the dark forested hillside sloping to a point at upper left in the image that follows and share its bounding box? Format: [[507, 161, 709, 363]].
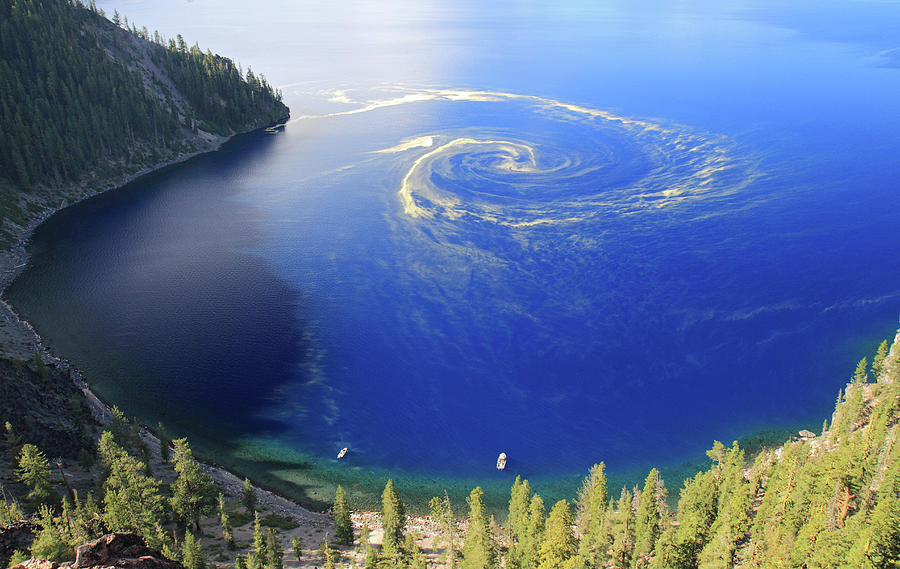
[[0, 0, 288, 246]]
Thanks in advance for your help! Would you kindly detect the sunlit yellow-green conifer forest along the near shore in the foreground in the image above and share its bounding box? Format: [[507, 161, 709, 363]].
[[0, 335, 900, 569]]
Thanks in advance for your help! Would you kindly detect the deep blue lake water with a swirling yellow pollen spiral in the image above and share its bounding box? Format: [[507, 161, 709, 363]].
[[8, 0, 900, 505]]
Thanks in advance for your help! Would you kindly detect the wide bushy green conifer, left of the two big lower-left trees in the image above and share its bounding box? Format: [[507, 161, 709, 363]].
[[99, 431, 164, 538]]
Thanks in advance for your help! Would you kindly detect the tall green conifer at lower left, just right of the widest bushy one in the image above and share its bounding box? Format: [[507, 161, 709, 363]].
[[170, 439, 218, 531]]
